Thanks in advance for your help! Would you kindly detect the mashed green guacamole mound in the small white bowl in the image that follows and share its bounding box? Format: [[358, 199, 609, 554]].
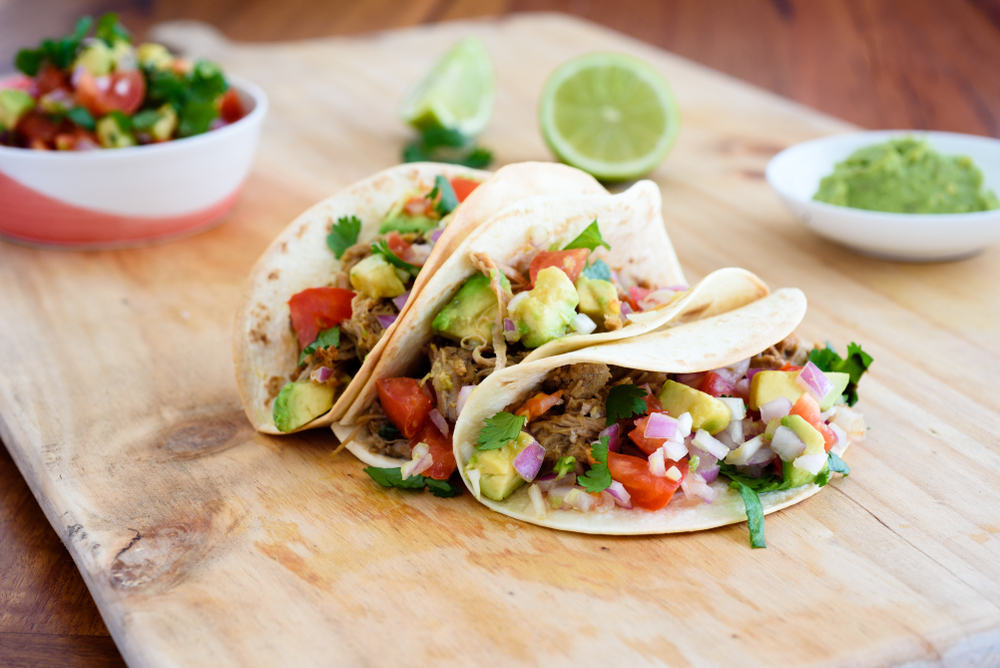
[[813, 138, 1000, 213]]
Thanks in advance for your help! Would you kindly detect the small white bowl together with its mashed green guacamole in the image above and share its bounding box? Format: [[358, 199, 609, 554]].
[[767, 130, 1000, 261]]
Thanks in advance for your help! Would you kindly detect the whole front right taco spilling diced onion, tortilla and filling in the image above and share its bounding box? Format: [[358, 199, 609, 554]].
[[454, 289, 871, 546]]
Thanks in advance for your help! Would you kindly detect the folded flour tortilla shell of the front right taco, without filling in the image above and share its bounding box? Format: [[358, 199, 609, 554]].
[[454, 288, 836, 535]]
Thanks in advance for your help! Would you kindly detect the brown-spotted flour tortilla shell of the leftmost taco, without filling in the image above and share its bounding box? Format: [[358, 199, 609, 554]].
[[233, 163, 607, 434]]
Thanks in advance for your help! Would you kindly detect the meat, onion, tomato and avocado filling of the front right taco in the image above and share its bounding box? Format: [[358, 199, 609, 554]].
[[464, 335, 872, 547]]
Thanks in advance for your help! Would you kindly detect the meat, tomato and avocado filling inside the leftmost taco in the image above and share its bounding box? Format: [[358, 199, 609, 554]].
[[272, 175, 479, 434]]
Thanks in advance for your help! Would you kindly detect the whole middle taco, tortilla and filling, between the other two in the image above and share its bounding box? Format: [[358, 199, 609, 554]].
[[333, 181, 766, 480]]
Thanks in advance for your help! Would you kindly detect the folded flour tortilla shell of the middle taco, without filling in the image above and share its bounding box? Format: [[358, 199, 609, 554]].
[[333, 181, 767, 468]]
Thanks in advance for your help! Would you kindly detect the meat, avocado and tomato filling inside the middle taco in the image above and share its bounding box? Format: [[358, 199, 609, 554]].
[[358, 220, 687, 491]]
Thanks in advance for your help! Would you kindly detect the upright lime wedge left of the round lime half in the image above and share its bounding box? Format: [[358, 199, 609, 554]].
[[399, 37, 496, 137]]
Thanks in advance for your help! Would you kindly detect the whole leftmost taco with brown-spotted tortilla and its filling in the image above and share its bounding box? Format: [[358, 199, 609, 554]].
[[233, 163, 606, 434]]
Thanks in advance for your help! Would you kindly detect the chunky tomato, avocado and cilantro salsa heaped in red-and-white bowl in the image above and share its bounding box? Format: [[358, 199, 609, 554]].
[[0, 13, 246, 151]]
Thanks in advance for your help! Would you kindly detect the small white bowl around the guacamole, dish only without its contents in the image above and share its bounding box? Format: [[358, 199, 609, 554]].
[[767, 130, 1000, 261]]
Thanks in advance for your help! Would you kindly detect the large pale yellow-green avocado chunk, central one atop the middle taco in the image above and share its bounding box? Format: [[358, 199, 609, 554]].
[[510, 267, 580, 348]]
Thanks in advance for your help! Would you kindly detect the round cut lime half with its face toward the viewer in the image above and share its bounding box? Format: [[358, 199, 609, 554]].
[[539, 53, 680, 181]]
